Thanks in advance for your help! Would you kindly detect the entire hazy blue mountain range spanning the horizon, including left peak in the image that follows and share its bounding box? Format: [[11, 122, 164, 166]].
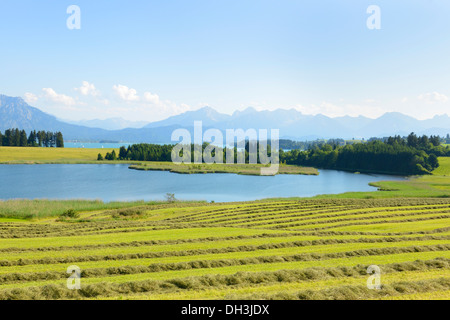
[[0, 95, 450, 143]]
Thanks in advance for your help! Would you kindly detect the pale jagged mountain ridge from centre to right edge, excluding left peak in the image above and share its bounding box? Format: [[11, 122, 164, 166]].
[[146, 107, 450, 140]]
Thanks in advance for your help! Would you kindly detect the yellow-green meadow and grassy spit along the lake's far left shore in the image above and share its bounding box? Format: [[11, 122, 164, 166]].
[[0, 147, 318, 175]]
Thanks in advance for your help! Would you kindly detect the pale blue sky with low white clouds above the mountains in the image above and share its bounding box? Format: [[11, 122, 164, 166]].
[[0, 0, 450, 121]]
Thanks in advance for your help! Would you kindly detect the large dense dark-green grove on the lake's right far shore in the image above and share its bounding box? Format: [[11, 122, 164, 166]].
[[280, 133, 450, 175]]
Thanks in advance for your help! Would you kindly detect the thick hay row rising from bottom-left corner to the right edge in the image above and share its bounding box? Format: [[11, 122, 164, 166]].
[[0, 259, 450, 300]]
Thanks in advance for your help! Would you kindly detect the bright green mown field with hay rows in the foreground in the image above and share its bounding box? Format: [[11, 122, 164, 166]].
[[0, 198, 450, 300]]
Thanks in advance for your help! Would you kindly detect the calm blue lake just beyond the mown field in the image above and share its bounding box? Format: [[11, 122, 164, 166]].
[[0, 164, 405, 202]]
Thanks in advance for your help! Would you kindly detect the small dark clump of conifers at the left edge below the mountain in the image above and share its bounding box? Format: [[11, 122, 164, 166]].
[[0, 128, 64, 148]]
